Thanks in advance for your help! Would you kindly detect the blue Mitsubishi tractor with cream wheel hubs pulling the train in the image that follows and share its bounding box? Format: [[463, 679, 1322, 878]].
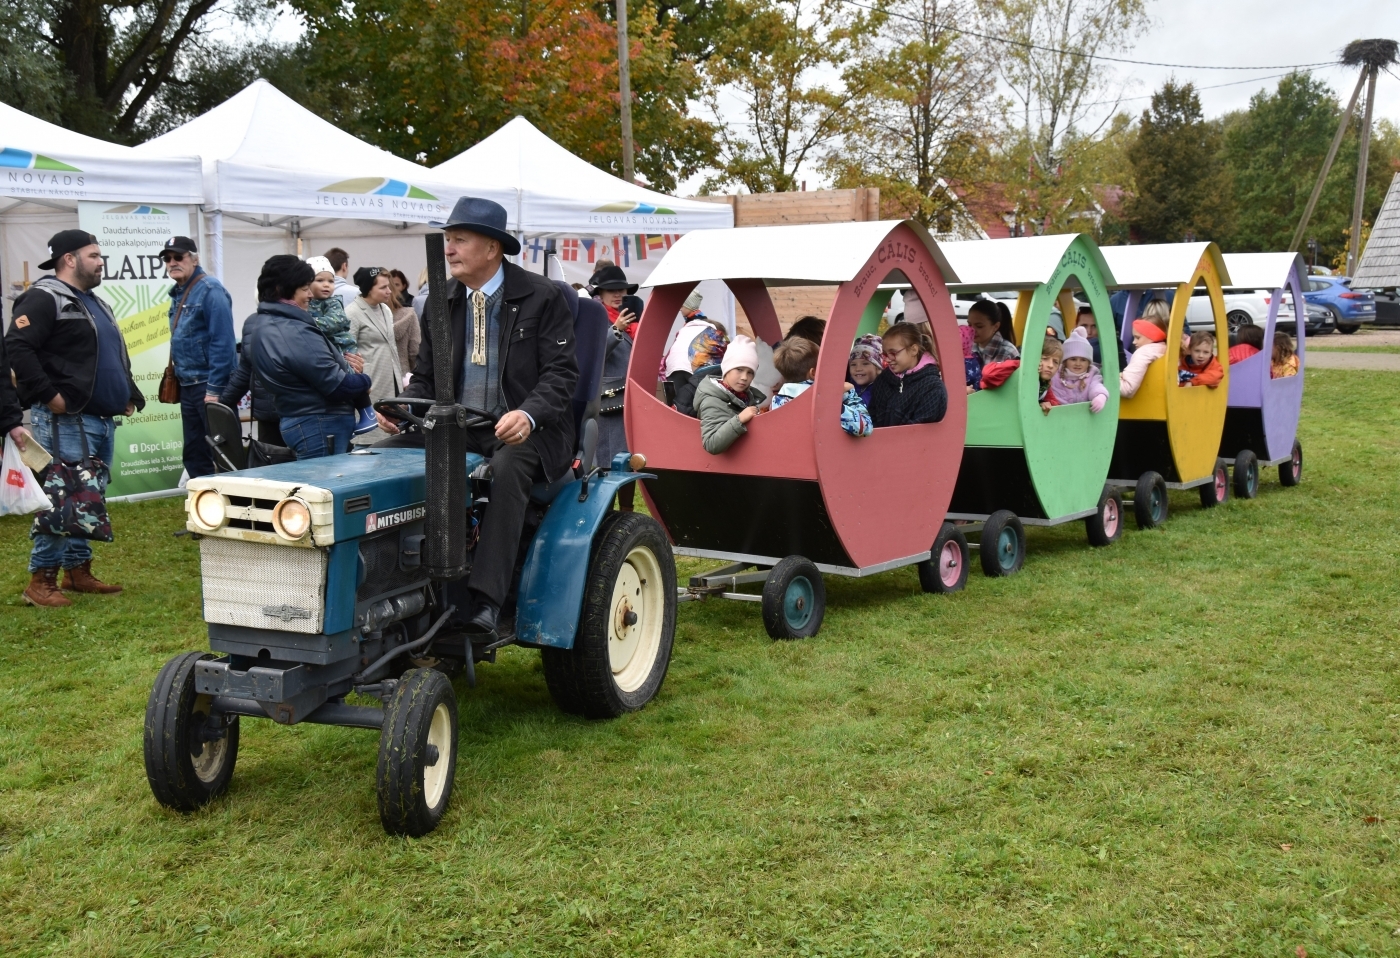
[[144, 234, 676, 836]]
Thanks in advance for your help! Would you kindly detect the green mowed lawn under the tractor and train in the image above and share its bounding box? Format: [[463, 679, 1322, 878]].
[[0, 371, 1400, 958]]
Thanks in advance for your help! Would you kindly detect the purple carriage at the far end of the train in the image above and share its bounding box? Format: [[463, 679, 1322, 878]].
[[1219, 254, 1308, 499]]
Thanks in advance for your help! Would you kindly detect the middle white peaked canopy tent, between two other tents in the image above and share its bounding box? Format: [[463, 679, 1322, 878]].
[[136, 80, 478, 322]]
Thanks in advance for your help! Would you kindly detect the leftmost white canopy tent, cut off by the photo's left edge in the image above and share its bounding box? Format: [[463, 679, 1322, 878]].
[[0, 104, 203, 322]]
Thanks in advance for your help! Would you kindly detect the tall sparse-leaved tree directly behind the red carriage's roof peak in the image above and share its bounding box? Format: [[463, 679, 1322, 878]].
[[825, 0, 995, 232]]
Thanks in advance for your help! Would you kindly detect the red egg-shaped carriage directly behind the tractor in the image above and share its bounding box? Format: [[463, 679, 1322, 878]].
[[624, 221, 967, 637]]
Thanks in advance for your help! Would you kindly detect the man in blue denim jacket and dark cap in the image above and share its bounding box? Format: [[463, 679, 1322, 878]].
[[161, 237, 238, 479]]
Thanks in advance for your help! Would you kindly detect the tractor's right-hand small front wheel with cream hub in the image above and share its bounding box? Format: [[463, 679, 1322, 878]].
[[375, 668, 456, 838]]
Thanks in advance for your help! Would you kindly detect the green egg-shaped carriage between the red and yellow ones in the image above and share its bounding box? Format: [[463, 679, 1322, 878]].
[[939, 234, 1123, 576]]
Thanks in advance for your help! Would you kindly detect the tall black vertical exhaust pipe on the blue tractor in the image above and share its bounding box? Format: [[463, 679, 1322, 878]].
[[423, 232, 466, 580]]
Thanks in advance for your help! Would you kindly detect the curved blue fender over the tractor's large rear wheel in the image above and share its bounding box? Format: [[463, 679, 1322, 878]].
[[515, 472, 655, 648]]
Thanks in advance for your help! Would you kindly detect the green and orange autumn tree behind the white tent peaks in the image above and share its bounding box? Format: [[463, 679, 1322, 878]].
[[293, 0, 713, 189]]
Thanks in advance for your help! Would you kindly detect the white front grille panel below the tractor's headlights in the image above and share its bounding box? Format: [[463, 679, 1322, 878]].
[[199, 536, 328, 633]]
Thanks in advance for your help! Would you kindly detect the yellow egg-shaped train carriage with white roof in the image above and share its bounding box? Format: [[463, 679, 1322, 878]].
[[1102, 242, 1231, 528]]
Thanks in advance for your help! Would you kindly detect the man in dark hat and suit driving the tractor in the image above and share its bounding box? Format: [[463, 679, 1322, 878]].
[[379, 196, 578, 633]]
